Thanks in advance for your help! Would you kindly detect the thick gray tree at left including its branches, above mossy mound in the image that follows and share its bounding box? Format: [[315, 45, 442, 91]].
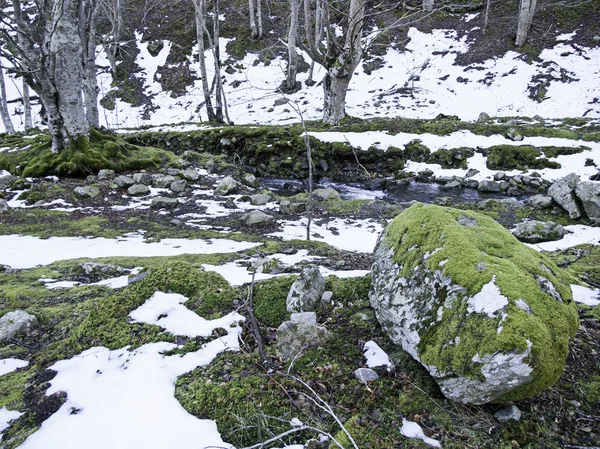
[[0, 0, 94, 152]]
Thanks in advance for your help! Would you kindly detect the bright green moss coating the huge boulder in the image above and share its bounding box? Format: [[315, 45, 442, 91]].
[[386, 204, 578, 401]]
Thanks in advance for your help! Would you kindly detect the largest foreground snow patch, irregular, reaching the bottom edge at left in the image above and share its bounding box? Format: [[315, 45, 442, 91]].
[[20, 293, 243, 449]]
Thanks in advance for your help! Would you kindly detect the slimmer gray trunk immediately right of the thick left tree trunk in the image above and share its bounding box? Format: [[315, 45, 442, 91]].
[[79, 0, 100, 128]]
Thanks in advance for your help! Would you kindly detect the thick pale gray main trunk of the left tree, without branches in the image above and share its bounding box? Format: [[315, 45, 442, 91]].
[[45, 0, 90, 151]]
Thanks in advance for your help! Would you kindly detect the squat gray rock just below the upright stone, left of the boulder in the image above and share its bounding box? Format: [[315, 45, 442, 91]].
[[275, 321, 332, 362]]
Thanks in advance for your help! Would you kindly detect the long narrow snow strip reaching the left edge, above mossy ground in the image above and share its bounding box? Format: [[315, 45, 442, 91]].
[[0, 234, 260, 268]]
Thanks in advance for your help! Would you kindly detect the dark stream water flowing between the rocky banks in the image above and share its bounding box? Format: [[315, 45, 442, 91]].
[[263, 178, 527, 203]]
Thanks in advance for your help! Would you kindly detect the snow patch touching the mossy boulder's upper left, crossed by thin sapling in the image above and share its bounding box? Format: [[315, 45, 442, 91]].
[[270, 218, 383, 253]]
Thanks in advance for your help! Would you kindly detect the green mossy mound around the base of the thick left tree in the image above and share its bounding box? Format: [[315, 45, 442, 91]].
[[0, 129, 176, 177]]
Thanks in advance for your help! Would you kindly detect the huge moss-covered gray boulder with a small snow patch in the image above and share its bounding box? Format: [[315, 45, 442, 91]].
[[369, 204, 578, 404]]
